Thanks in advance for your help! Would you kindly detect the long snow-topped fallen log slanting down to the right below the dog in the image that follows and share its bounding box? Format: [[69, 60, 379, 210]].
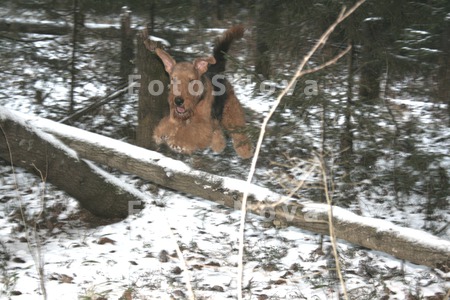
[[1, 108, 450, 271]]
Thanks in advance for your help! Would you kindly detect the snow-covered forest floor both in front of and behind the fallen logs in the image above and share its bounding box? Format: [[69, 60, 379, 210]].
[[0, 7, 450, 299]]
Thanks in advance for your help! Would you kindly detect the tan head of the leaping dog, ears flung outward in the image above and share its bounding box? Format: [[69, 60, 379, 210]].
[[155, 48, 216, 120]]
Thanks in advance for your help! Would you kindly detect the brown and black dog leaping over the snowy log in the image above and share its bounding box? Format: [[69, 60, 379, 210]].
[[153, 25, 253, 158]]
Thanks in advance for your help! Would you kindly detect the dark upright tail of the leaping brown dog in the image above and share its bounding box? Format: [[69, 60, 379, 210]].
[[209, 25, 245, 73]]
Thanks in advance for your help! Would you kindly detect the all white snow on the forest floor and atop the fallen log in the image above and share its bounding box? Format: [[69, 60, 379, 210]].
[[0, 11, 450, 299]]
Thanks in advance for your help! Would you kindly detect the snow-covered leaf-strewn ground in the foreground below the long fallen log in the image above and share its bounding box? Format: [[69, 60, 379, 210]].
[[0, 166, 448, 299]]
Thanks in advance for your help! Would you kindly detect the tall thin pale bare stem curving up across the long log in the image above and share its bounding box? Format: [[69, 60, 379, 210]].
[[237, 0, 365, 300]]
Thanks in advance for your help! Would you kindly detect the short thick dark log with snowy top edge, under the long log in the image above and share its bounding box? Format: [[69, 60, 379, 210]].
[[0, 107, 144, 218]]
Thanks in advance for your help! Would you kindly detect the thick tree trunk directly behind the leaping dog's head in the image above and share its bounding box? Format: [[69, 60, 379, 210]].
[[136, 33, 169, 149]]
